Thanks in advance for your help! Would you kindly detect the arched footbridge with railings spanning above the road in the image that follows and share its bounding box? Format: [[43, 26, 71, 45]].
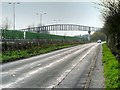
[[21, 24, 101, 32]]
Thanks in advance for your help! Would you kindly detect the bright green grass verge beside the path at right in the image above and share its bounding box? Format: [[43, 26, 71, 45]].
[[102, 44, 120, 88]]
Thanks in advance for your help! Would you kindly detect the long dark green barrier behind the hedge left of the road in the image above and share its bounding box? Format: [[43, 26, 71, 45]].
[[1, 30, 77, 40]]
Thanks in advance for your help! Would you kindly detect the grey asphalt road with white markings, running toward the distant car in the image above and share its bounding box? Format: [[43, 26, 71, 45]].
[[0, 43, 101, 88]]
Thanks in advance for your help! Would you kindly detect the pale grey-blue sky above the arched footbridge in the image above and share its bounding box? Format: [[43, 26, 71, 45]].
[[0, 0, 103, 34]]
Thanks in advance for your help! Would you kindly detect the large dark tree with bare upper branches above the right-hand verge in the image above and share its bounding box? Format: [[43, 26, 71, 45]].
[[99, 0, 120, 54]]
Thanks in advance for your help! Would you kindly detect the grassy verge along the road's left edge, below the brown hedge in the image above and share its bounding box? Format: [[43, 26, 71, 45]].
[[0, 43, 78, 63]]
